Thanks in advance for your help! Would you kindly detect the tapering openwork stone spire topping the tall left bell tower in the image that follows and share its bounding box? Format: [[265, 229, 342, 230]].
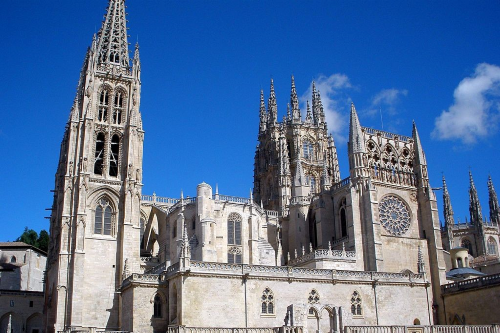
[[97, 0, 130, 69]]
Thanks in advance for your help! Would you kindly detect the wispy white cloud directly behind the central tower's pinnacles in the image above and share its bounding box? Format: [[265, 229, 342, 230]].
[[299, 73, 352, 142]]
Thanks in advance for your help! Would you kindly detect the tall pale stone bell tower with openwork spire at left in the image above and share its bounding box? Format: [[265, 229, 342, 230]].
[[45, 0, 144, 332]]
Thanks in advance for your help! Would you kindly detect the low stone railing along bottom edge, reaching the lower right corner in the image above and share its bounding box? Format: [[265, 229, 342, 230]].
[[344, 324, 500, 333]]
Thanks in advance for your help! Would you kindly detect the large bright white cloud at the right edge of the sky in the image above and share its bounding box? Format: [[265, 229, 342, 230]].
[[432, 63, 500, 144]]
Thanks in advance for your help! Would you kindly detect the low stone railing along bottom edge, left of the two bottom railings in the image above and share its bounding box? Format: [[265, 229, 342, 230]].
[[167, 326, 303, 333]]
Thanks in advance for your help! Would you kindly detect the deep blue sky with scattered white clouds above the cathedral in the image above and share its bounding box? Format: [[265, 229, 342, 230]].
[[0, 0, 500, 241]]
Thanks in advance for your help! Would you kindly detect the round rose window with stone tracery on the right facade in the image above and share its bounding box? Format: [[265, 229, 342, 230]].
[[378, 195, 411, 236]]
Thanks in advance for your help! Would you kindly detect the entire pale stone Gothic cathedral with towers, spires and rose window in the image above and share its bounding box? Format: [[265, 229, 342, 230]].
[[44, 0, 498, 333]]
